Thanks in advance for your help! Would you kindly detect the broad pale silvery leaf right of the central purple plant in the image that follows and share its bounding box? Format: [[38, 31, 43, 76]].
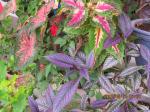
[[103, 56, 118, 70]]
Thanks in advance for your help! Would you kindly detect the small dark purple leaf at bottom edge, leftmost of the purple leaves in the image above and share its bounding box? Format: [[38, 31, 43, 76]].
[[28, 97, 40, 112]]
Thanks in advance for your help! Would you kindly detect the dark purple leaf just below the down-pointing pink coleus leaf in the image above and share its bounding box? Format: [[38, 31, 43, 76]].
[[104, 35, 122, 49]]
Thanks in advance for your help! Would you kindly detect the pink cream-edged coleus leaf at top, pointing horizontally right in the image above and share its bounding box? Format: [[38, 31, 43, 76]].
[[96, 2, 114, 12]]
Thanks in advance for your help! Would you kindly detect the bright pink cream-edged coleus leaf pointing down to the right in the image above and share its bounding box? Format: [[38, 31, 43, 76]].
[[94, 16, 110, 34]]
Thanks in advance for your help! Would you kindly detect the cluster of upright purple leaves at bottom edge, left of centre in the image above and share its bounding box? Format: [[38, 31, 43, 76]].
[[29, 78, 81, 112]]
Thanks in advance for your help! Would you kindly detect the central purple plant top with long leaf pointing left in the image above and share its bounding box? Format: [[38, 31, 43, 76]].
[[46, 51, 94, 80]]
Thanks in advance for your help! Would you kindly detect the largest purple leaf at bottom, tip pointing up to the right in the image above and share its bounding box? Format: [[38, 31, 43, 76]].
[[53, 78, 80, 112]]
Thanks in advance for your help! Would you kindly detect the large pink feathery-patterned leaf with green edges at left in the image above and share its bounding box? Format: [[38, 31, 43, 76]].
[[16, 30, 36, 65]]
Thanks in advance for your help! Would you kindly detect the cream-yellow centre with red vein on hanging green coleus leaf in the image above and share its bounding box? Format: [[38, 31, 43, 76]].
[[95, 28, 103, 48]]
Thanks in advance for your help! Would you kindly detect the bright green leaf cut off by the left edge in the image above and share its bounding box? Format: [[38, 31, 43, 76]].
[[0, 61, 7, 80]]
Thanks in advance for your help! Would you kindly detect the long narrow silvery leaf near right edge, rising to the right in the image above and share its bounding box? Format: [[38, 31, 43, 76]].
[[118, 66, 143, 77]]
